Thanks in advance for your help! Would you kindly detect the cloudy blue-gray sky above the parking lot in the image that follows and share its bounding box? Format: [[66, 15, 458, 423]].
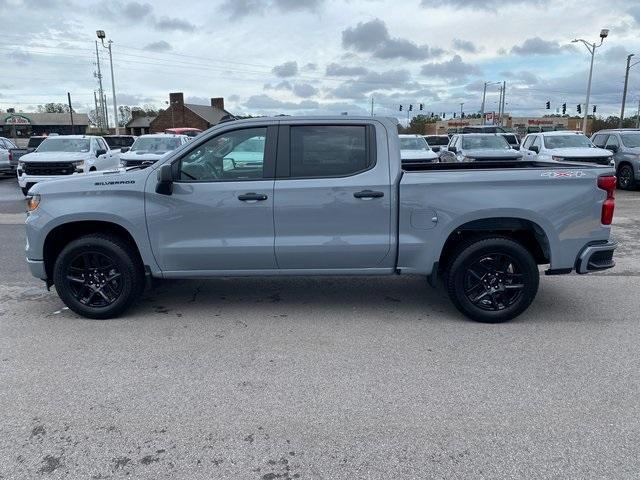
[[0, 0, 640, 124]]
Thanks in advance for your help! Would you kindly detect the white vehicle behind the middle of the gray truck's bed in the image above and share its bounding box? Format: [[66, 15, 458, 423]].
[[440, 133, 522, 162]]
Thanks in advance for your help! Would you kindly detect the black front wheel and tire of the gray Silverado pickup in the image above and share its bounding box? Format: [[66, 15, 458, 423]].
[[53, 234, 144, 319]]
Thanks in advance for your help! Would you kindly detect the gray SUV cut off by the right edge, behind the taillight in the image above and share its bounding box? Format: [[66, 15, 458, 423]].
[[591, 128, 640, 190]]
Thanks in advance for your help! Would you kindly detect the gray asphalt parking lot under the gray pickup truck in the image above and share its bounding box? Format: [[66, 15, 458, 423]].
[[0, 179, 640, 480]]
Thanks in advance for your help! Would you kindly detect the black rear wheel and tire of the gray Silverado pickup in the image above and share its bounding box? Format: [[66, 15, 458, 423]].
[[445, 237, 540, 323]]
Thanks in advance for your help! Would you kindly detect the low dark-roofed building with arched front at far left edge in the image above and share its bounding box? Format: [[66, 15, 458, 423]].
[[0, 112, 89, 140]]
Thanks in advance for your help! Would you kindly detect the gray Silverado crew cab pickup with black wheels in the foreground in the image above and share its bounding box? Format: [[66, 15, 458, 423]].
[[26, 116, 616, 322]]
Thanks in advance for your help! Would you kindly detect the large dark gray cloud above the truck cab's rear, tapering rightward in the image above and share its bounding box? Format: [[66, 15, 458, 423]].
[[342, 18, 444, 60]]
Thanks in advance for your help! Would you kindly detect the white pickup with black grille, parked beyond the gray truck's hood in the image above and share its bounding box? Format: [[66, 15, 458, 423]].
[[16, 135, 120, 195]]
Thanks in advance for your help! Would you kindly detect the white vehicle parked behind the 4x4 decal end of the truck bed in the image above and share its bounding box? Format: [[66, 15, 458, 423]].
[[520, 131, 613, 165]]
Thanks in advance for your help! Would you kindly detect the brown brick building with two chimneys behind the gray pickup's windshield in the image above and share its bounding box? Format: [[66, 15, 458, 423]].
[[149, 92, 230, 133]]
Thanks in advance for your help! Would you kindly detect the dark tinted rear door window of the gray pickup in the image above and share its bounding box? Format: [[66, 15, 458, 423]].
[[289, 125, 372, 178]]
